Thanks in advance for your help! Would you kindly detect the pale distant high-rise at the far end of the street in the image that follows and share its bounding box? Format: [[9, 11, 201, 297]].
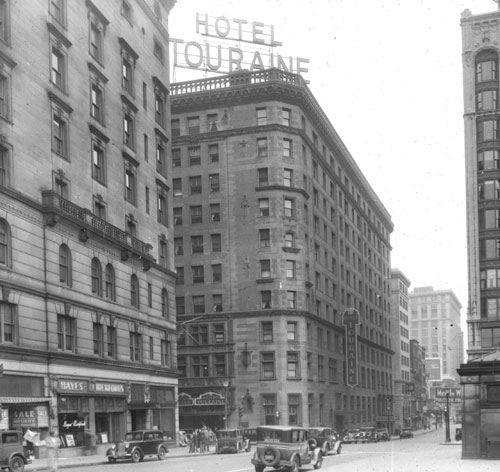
[[409, 287, 463, 381]]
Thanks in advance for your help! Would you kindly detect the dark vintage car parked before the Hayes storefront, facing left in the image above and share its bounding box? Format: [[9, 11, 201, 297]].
[[106, 429, 168, 462]]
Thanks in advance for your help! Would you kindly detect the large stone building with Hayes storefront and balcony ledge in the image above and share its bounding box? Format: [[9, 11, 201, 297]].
[[0, 0, 177, 455]]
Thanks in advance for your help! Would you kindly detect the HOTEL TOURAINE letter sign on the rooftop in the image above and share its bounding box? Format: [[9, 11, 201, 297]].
[[170, 13, 309, 78]]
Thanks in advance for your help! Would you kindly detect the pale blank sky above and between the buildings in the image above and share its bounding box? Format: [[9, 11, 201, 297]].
[[169, 0, 498, 330]]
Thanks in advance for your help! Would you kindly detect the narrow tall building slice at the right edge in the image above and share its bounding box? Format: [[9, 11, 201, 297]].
[[458, 4, 500, 458]]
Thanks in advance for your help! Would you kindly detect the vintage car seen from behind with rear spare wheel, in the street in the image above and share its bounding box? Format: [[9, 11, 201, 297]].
[[251, 426, 323, 472]]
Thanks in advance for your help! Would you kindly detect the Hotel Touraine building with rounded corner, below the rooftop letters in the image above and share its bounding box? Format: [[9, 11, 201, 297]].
[[171, 69, 394, 432]]
